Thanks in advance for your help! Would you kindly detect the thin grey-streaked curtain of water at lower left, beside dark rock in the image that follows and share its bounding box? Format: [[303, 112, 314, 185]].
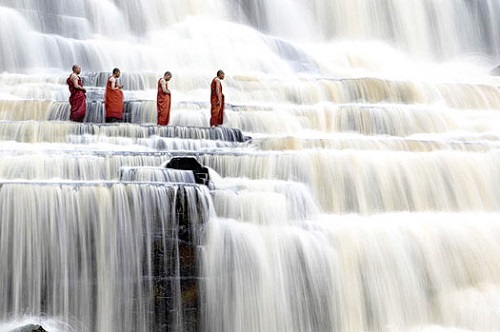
[[0, 182, 211, 331]]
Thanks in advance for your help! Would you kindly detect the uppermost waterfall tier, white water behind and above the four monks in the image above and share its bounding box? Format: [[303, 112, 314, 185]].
[[0, 0, 500, 74]]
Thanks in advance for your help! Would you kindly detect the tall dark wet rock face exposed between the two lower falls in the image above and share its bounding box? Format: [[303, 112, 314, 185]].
[[148, 187, 206, 332]]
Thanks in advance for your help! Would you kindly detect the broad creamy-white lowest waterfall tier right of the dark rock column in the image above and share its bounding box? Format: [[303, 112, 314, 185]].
[[204, 214, 500, 331]]
